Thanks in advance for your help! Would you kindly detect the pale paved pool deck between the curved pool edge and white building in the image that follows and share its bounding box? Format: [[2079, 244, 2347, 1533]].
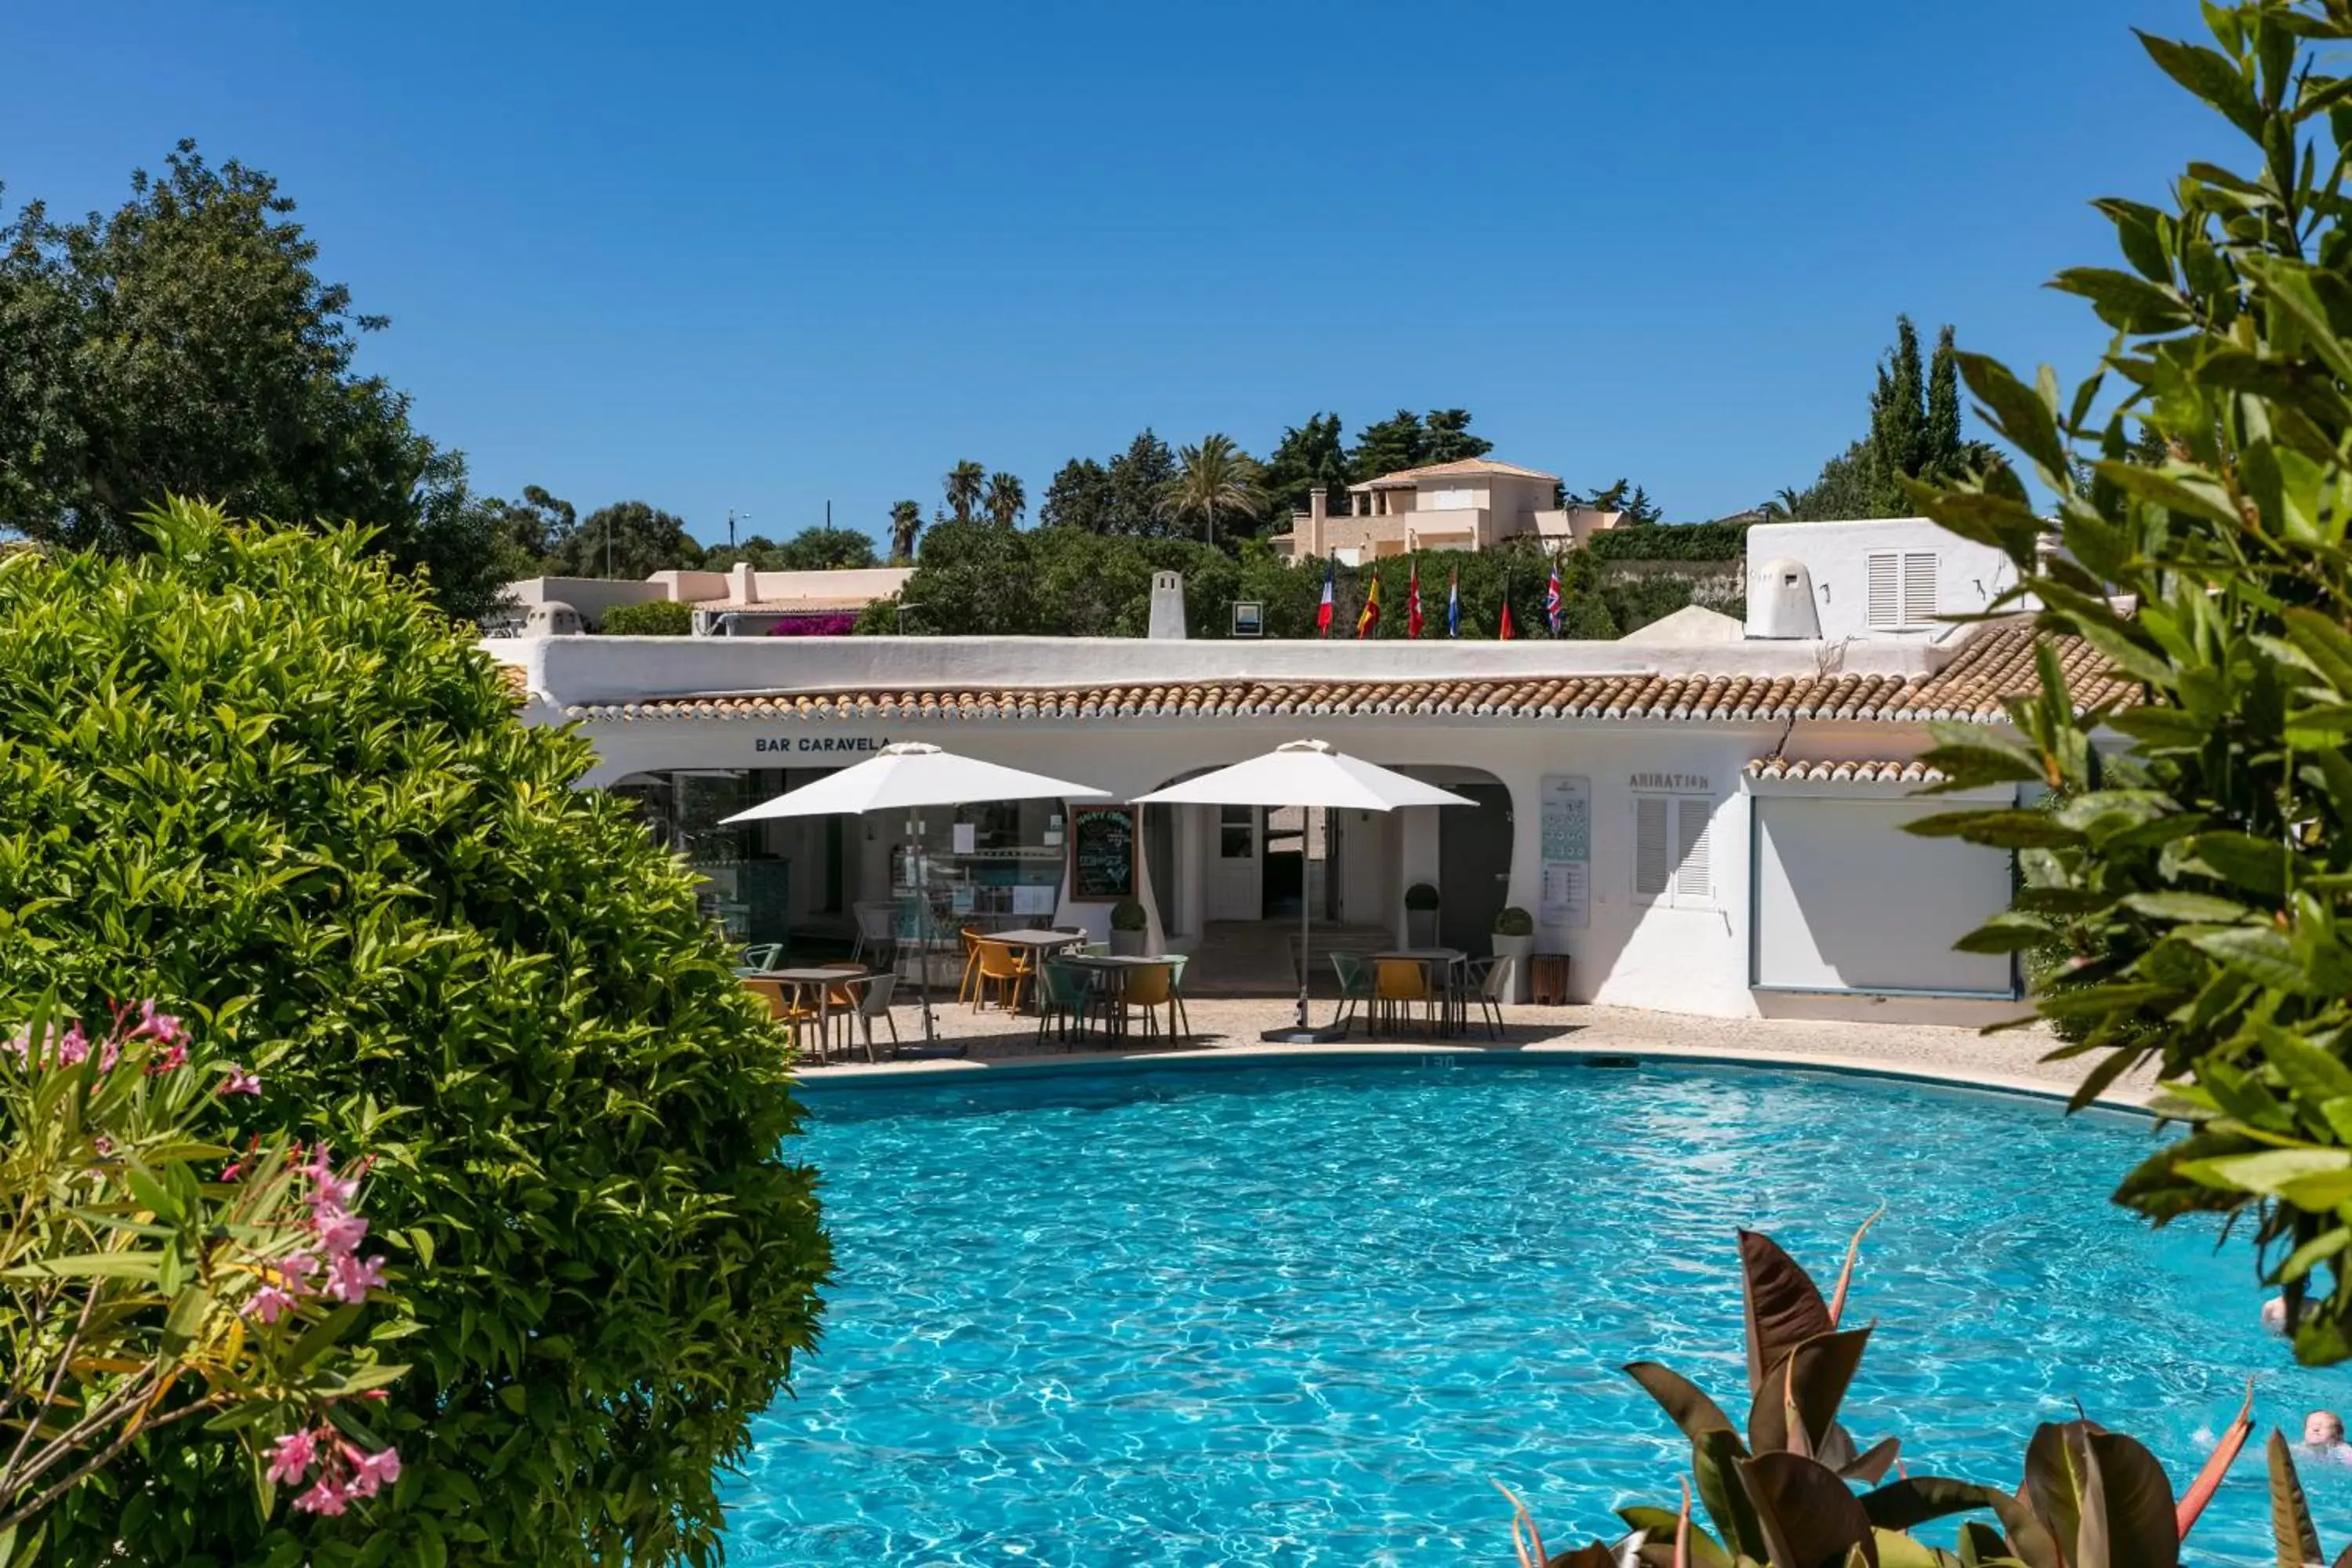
[[802, 996, 2154, 1107]]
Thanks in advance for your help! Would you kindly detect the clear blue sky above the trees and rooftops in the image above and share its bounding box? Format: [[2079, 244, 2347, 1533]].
[[0, 0, 2211, 552]]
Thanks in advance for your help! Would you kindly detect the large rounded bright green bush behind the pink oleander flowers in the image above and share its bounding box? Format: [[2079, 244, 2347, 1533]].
[[0, 503, 828, 1563]]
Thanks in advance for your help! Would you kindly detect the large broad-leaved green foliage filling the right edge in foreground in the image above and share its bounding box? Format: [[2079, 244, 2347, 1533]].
[[1915, 0, 2352, 1363]]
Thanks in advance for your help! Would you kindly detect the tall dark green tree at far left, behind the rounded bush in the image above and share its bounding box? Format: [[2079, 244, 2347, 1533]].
[[0, 141, 503, 619]]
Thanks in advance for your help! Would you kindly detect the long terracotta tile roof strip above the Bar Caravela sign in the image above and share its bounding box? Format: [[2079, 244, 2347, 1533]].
[[569, 621, 2138, 724]]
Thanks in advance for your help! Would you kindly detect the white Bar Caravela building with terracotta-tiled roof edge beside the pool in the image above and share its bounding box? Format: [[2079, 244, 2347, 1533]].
[[489, 522, 2122, 1020]]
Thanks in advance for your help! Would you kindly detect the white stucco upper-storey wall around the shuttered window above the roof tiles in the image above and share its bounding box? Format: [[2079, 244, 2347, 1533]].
[[1748, 517, 2018, 647]]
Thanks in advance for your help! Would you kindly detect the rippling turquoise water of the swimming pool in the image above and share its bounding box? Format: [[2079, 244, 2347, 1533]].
[[727, 1062, 2352, 1568]]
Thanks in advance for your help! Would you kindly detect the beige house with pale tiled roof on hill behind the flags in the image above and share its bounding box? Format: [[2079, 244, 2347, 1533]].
[[1268, 459, 1618, 567]]
